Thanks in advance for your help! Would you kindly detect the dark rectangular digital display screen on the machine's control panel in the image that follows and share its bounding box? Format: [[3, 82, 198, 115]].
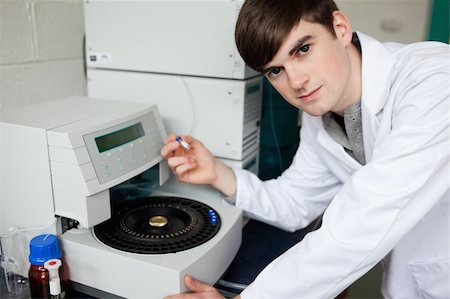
[[95, 123, 145, 153]]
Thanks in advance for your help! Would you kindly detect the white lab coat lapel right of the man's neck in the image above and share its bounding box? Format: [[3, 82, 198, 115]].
[[357, 32, 394, 163]]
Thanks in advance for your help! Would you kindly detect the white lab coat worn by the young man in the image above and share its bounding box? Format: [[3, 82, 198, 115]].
[[234, 33, 450, 299]]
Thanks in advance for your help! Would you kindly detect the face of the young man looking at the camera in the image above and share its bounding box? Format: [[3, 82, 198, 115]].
[[263, 12, 360, 116]]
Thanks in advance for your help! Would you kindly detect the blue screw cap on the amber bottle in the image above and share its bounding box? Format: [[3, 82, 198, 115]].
[[29, 234, 61, 266]]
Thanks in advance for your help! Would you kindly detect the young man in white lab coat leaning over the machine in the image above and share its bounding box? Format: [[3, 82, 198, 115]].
[[161, 0, 450, 299]]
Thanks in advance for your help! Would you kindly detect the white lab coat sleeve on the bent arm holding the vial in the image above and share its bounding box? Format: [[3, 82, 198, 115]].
[[234, 122, 341, 231]]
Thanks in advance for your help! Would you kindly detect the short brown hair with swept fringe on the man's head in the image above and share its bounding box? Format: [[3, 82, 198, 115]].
[[235, 0, 338, 72]]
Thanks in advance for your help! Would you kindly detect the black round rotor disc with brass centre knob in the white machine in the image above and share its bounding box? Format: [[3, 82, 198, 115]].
[[94, 197, 220, 254]]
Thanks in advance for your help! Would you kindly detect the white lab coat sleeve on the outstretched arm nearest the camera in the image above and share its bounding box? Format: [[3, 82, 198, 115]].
[[241, 51, 450, 299]]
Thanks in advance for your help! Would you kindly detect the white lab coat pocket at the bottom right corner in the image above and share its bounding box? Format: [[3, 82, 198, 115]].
[[408, 259, 450, 299]]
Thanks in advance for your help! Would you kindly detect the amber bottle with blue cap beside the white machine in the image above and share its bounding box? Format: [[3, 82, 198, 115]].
[[28, 234, 61, 298]]
